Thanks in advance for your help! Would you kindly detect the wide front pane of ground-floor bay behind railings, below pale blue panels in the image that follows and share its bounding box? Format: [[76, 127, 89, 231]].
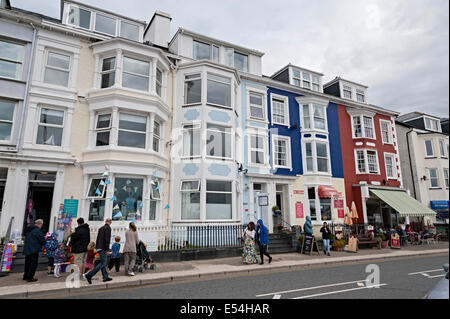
[[206, 181, 233, 220]]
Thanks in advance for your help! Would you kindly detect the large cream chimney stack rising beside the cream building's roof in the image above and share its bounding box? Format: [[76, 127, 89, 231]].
[[144, 11, 172, 48]]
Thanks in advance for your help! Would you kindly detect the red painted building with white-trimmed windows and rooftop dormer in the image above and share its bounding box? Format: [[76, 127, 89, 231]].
[[324, 78, 404, 226]]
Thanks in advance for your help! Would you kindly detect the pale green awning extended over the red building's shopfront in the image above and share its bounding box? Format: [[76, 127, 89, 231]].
[[370, 189, 436, 217]]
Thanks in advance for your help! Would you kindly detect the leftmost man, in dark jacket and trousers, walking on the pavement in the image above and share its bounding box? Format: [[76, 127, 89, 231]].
[[23, 219, 45, 282]]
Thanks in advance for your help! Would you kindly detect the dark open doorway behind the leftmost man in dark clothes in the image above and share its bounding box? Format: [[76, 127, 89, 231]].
[[24, 172, 56, 233]]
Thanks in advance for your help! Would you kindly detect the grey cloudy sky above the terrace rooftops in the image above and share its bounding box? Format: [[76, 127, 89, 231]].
[[11, 0, 449, 117]]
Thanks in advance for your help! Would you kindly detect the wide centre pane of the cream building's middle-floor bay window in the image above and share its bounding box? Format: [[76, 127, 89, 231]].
[[118, 113, 147, 148]]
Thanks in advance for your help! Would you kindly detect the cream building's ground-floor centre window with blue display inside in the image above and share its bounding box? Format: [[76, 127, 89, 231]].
[[112, 177, 144, 221]]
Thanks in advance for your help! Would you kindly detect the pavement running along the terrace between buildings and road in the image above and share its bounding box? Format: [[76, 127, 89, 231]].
[[0, 242, 449, 298]]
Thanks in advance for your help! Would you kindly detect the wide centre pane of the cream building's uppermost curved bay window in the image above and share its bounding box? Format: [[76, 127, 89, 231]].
[[122, 56, 150, 91]]
